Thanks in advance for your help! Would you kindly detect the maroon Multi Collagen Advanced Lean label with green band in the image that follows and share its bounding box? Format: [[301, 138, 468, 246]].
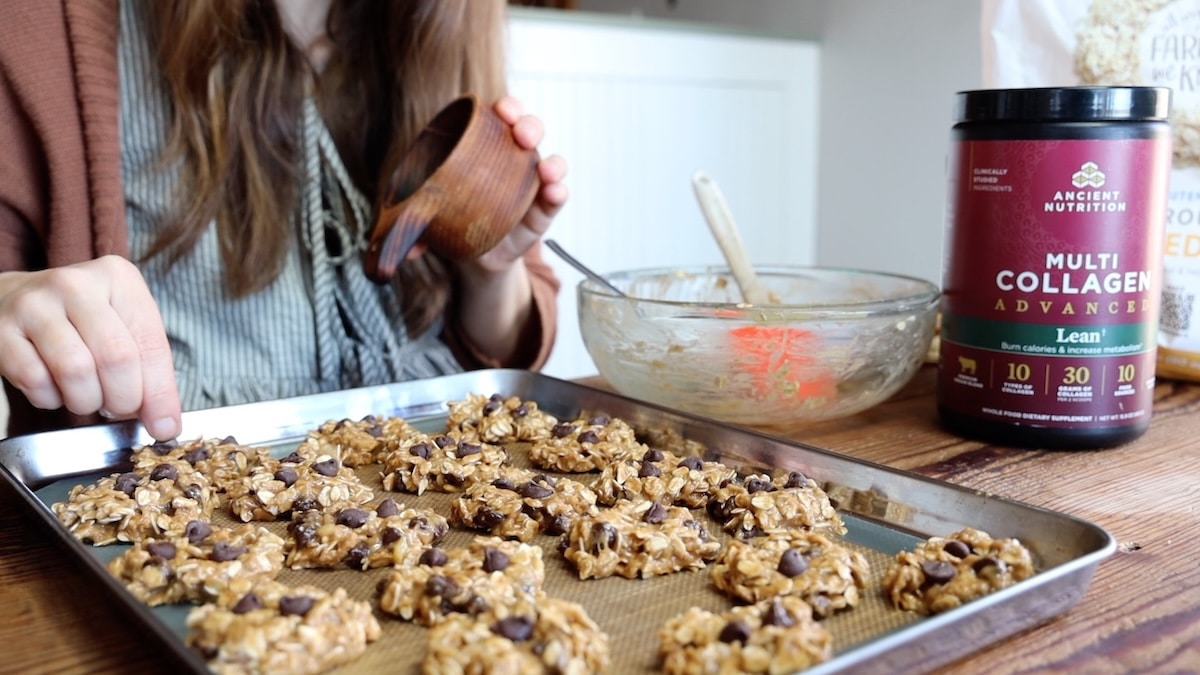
[[938, 139, 1170, 429]]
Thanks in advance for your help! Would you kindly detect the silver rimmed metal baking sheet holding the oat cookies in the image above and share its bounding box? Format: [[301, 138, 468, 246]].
[[0, 370, 1116, 674]]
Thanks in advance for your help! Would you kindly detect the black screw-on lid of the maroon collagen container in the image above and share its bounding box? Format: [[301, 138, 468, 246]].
[[954, 86, 1171, 123]]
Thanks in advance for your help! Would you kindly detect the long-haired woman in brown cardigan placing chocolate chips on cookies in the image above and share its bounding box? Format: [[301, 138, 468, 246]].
[[0, 0, 566, 440]]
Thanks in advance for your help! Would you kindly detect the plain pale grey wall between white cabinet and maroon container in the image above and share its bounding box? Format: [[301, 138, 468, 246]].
[[578, 0, 982, 282]]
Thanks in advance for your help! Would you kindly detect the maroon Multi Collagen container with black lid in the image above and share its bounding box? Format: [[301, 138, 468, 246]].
[[937, 86, 1171, 448]]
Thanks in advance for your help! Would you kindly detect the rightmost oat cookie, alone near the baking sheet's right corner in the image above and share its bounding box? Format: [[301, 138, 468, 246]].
[[883, 527, 1037, 614]]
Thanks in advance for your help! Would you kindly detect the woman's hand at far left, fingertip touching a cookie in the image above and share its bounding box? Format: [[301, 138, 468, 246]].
[[0, 256, 181, 441]]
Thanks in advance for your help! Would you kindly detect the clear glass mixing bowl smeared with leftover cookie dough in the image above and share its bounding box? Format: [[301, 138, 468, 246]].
[[577, 265, 940, 428]]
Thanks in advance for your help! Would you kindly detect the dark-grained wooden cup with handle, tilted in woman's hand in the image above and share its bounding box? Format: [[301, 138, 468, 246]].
[[364, 95, 541, 283]]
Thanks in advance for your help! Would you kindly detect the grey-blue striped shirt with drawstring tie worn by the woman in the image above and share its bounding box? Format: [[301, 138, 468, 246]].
[[118, 0, 462, 410]]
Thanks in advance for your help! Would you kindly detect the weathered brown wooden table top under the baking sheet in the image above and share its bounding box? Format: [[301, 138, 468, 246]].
[[0, 366, 1200, 674]]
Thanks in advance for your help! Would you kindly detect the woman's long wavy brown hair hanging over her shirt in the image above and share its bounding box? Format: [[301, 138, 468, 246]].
[[145, 0, 505, 329]]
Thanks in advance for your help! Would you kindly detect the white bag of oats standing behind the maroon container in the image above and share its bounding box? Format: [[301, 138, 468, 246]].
[[982, 0, 1200, 381]]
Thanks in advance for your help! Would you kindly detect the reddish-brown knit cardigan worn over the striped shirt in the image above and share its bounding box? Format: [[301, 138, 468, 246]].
[[0, 0, 559, 435]]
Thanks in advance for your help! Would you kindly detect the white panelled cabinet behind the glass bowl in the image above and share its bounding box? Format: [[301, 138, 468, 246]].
[[509, 11, 818, 377]]
